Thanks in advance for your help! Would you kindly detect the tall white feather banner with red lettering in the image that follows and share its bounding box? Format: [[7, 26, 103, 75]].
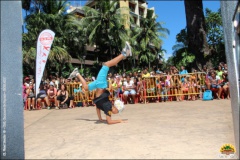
[[36, 29, 55, 96]]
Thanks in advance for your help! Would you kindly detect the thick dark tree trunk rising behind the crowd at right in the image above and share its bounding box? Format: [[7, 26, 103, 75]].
[[184, 0, 209, 68]]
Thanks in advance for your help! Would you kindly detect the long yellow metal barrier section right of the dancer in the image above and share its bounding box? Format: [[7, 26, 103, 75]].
[[143, 72, 206, 103]]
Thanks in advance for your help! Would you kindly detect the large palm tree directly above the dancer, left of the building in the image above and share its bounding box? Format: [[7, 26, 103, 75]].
[[69, 0, 128, 59]]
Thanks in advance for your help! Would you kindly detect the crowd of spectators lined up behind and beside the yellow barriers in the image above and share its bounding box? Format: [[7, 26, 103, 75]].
[[23, 62, 230, 110]]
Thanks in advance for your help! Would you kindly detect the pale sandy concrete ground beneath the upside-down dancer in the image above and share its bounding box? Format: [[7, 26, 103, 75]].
[[24, 100, 235, 159]]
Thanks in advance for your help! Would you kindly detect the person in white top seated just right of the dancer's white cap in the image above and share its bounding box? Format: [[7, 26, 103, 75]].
[[123, 75, 136, 104]]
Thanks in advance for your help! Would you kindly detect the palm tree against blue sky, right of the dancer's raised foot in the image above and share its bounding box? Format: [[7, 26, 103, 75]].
[[130, 10, 169, 66]]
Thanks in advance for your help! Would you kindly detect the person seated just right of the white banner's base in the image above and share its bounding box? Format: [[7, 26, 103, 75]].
[[37, 83, 50, 109]]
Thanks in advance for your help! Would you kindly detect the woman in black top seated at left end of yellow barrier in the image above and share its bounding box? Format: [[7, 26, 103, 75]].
[[56, 84, 74, 109]]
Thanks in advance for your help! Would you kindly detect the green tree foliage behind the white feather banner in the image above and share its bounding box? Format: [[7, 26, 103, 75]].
[[22, 0, 76, 76]]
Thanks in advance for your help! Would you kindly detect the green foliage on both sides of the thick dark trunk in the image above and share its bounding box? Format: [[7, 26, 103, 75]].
[[167, 8, 226, 70]]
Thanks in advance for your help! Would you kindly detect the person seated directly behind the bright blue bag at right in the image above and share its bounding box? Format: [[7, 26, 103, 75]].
[[209, 72, 222, 100]]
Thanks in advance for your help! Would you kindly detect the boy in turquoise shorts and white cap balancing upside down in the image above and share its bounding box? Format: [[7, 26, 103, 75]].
[[69, 42, 132, 124]]
